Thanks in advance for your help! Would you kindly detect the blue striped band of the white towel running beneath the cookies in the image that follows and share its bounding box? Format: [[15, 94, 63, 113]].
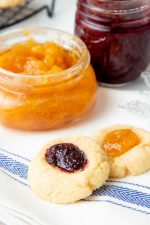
[[0, 146, 150, 215]]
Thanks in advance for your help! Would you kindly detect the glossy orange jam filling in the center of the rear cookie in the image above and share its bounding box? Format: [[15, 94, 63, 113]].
[[103, 129, 140, 157]]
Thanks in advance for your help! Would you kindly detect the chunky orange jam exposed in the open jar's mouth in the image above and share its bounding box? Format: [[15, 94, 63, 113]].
[[0, 39, 78, 75]]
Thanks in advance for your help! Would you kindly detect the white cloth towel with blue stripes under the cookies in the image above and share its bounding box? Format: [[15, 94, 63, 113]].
[[0, 88, 150, 225]]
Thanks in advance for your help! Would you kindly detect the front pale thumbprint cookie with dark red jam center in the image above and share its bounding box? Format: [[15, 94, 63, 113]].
[[28, 136, 110, 204]]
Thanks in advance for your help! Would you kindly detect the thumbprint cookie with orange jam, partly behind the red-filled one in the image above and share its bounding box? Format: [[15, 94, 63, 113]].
[[92, 125, 150, 178]]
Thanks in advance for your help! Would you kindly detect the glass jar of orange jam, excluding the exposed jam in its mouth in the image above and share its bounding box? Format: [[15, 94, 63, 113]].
[[0, 28, 97, 130]]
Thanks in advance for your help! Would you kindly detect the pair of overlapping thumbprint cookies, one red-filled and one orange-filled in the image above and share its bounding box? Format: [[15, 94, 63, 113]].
[[28, 125, 150, 204]]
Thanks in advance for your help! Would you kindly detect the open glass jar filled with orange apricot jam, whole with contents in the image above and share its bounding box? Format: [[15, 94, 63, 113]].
[[0, 28, 97, 131]]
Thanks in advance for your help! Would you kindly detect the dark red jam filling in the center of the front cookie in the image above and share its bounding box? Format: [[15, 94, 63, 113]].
[[45, 143, 87, 173]]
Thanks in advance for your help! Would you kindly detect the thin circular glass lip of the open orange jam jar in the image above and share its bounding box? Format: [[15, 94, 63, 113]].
[[0, 26, 90, 80]]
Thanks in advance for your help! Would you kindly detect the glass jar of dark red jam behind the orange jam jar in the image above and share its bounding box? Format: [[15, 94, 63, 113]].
[[75, 0, 150, 86]]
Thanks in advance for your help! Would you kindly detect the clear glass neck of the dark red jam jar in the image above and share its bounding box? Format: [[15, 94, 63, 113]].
[[77, 0, 150, 22]]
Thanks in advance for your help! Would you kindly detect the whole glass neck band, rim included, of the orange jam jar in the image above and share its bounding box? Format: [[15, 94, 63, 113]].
[[0, 28, 90, 94]]
